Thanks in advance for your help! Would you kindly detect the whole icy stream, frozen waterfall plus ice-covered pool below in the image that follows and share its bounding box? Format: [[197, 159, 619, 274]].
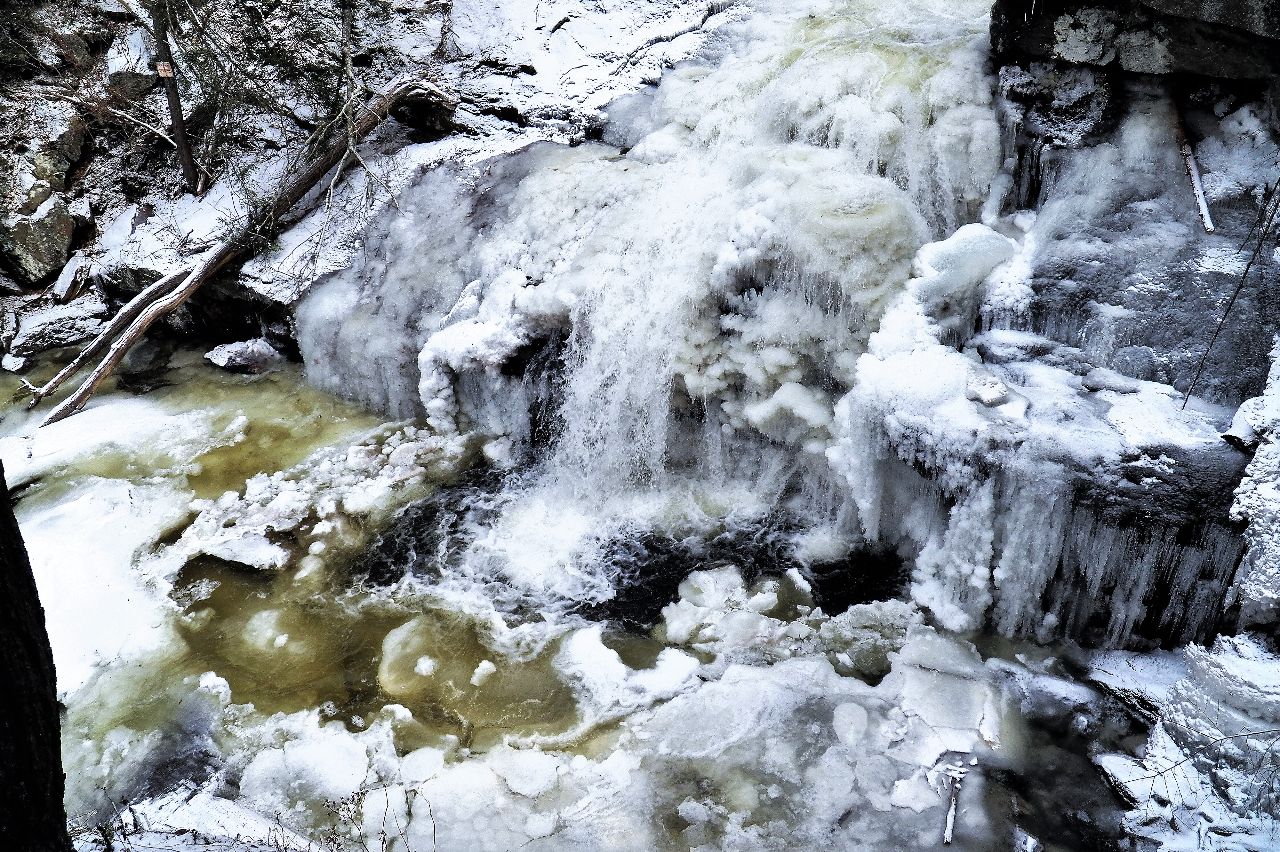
[[0, 0, 1280, 852]]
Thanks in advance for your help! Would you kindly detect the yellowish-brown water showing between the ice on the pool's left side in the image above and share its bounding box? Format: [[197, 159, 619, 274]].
[[0, 353, 593, 751]]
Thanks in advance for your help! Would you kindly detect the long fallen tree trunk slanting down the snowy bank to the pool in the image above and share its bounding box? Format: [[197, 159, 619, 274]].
[[29, 78, 456, 426]]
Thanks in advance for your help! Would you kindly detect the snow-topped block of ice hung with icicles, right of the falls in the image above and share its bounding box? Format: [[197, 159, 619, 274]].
[[828, 212, 1240, 647]]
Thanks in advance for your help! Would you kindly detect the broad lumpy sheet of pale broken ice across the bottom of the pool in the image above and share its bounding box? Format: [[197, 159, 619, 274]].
[[76, 569, 1021, 852]]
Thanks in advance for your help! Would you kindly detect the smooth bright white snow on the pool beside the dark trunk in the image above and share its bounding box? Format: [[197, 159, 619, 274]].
[[0, 399, 241, 696]]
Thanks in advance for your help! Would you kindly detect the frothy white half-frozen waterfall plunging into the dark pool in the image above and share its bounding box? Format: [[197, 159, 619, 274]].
[[298, 3, 1000, 629]]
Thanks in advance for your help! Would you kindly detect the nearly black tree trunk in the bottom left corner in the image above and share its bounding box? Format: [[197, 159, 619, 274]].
[[0, 464, 72, 852]]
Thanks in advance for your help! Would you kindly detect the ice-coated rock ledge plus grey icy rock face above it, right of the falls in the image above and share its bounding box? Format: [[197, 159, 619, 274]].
[[832, 84, 1276, 646]]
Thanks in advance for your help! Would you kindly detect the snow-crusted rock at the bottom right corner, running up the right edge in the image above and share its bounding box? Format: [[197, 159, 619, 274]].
[[1094, 337, 1280, 849]]
